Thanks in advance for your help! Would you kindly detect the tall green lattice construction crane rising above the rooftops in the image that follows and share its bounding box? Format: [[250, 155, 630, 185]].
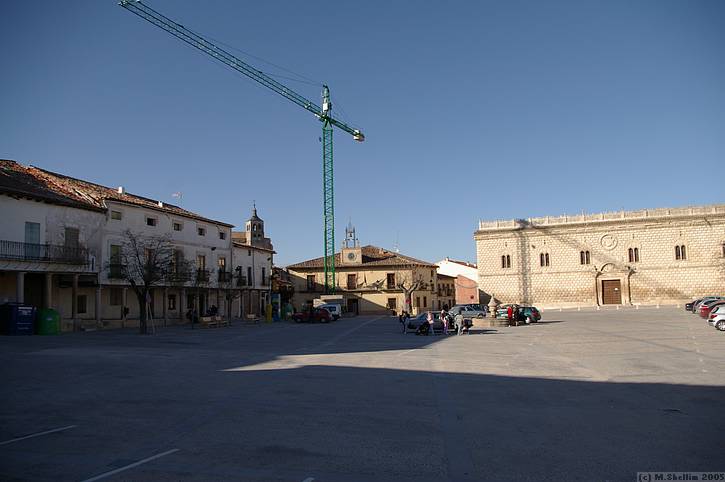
[[118, 0, 365, 293]]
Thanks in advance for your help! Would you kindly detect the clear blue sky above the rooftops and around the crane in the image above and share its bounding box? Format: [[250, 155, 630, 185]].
[[0, 0, 725, 265]]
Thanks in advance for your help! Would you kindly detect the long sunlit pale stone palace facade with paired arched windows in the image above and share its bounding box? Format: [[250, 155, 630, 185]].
[[474, 205, 725, 307]]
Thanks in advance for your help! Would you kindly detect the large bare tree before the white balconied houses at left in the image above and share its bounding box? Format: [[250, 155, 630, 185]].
[[106, 229, 173, 334]]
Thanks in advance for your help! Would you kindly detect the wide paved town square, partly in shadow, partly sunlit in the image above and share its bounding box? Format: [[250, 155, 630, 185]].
[[0, 306, 725, 481]]
